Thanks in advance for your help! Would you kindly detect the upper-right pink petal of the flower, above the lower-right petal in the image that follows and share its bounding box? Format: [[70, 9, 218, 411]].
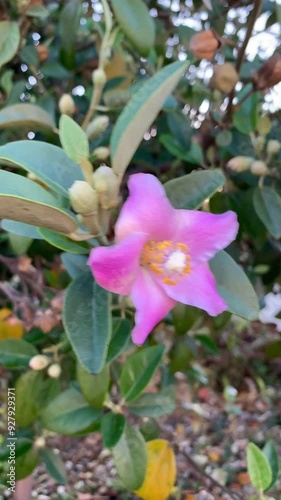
[[174, 210, 238, 267]]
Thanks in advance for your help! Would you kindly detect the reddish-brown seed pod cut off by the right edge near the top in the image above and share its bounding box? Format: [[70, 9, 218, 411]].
[[252, 54, 281, 90]]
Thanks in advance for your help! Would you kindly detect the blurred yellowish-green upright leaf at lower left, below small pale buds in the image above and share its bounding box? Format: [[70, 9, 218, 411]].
[[15, 370, 42, 427]]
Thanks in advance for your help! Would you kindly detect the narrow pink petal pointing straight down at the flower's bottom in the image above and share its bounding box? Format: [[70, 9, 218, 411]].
[[131, 268, 175, 345]]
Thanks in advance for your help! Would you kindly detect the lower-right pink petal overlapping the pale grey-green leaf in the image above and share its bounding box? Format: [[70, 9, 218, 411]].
[[157, 264, 227, 316]]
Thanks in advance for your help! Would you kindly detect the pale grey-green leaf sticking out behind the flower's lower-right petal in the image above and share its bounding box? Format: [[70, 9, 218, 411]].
[[210, 251, 259, 321]]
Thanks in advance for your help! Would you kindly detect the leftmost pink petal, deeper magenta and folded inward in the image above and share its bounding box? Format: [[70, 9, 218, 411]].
[[88, 233, 148, 295]]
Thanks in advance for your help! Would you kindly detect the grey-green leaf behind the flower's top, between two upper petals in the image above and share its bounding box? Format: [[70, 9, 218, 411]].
[[164, 169, 225, 210]]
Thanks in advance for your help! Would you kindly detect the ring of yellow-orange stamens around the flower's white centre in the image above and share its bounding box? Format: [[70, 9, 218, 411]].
[[141, 240, 191, 285]]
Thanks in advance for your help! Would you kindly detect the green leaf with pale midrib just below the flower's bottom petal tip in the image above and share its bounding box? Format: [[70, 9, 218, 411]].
[[120, 345, 164, 402]]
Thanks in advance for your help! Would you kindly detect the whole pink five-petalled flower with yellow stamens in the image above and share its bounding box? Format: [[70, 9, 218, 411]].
[[89, 174, 238, 345]]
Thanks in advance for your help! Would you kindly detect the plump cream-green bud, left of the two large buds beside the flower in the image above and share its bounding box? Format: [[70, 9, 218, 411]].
[[68, 181, 98, 214]]
